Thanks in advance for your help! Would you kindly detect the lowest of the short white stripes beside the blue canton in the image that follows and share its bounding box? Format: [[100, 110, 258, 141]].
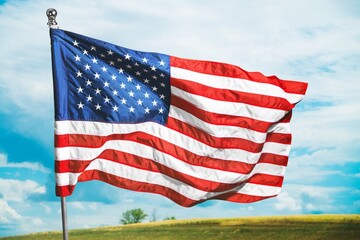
[[169, 106, 290, 143]]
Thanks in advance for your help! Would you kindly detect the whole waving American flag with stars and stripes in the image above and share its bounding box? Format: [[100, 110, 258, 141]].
[[50, 29, 307, 207]]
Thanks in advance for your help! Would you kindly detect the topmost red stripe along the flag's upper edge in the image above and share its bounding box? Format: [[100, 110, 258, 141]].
[[170, 56, 307, 95]]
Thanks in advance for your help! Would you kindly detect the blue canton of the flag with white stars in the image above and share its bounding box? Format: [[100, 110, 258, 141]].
[[51, 29, 170, 124]]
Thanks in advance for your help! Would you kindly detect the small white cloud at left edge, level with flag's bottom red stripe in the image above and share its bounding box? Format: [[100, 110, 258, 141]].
[[0, 178, 46, 202]]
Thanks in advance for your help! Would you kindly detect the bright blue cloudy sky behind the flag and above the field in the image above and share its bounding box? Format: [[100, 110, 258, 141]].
[[0, 0, 360, 237]]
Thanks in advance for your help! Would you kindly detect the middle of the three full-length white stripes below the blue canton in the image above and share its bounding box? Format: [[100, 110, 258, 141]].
[[55, 140, 285, 183]]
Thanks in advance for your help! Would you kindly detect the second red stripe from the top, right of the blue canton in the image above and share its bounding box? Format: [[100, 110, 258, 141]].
[[171, 78, 294, 111]]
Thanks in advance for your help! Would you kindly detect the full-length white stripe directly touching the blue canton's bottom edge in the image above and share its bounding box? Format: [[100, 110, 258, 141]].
[[55, 121, 290, 163]]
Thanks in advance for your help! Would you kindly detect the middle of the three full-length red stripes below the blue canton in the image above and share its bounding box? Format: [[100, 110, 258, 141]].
[[55, 150, 283, 192]]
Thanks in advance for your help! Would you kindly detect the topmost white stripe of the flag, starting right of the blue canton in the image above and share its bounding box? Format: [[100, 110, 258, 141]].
[[170, 67, 304, 104]]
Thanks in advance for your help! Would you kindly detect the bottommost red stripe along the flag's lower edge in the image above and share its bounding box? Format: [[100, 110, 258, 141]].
[[56, 170, 276, 207]]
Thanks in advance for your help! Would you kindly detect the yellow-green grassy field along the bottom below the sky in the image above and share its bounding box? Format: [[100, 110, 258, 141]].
[[0, 214, 360, 240]]
